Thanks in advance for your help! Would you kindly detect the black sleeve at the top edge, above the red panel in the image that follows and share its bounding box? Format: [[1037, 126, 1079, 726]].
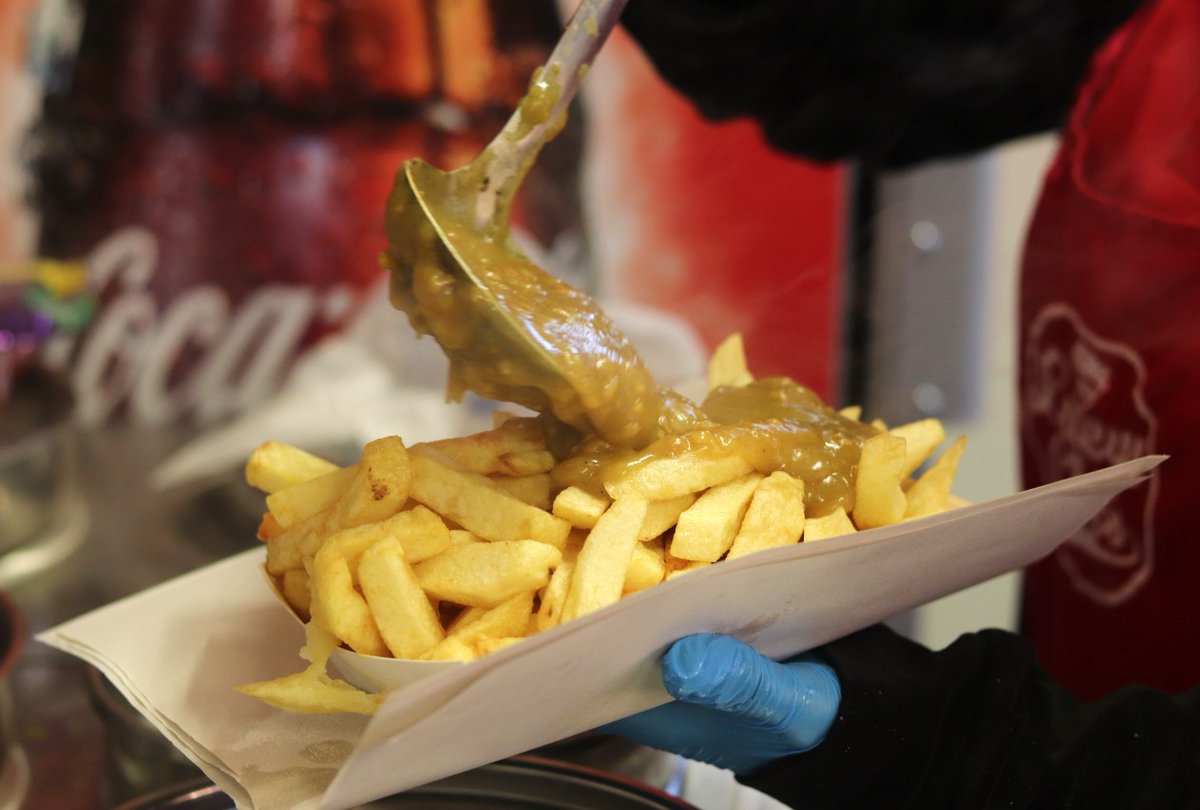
[[623, 0, 1140, 167]]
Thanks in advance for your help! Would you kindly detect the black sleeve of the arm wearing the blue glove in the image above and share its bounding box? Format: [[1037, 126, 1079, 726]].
[[742, 626, 1200, 810]]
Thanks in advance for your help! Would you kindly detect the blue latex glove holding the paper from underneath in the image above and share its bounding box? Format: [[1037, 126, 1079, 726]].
[[596, 632, 841, 774]]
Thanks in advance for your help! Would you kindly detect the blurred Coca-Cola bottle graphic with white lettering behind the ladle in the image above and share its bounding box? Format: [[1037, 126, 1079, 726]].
[[32, 0, 581, 425]]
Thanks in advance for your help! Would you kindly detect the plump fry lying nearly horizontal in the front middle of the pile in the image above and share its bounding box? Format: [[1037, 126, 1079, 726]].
[[414, 540, 563, 607]]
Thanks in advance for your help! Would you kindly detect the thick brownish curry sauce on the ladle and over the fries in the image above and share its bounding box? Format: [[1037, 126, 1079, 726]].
[[383, 58, 871, 514]]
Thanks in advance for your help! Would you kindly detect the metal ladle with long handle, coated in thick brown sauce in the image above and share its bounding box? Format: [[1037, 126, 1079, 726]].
[[383, 0, 685, 448]]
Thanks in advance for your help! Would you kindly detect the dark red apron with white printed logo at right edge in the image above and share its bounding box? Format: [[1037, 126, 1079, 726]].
[[1020, 0, 1200, 697]]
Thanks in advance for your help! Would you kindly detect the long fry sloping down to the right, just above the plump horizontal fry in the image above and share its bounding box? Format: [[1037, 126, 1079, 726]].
[[409, 446, 571, 548]]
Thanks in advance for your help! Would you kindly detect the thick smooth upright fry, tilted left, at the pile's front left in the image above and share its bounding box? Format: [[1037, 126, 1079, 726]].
[[358, 536, 449, 658]]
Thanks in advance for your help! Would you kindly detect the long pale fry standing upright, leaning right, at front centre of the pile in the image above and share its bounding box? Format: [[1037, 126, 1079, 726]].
[[562, 498, 647, 622]]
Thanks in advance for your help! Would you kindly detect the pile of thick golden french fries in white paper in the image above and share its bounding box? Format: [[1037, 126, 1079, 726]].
[[241, 336, 965, 713]]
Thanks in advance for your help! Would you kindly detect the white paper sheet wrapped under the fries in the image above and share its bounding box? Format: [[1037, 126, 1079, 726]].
[[38, 456, 1162, 810]]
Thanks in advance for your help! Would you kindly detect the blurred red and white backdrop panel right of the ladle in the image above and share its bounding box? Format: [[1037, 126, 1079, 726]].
[[584, 31, 846, 400]]
